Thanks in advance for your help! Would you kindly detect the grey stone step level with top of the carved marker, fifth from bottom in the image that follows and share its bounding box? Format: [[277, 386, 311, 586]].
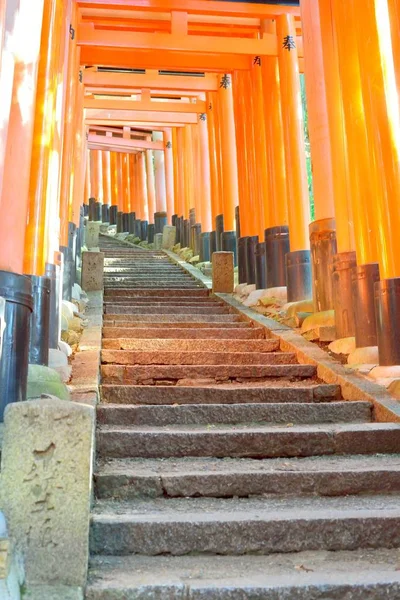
[[97, 402, 372, 426]]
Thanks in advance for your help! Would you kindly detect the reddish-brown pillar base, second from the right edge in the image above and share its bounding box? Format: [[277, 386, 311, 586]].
[[351, 263, 379, 348]]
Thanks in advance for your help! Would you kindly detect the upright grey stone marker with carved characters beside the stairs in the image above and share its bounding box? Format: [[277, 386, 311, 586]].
[[0, 398, 94, 600]]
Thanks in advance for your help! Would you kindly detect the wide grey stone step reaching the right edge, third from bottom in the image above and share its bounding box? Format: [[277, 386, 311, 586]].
[[95, 454, 400, 500]]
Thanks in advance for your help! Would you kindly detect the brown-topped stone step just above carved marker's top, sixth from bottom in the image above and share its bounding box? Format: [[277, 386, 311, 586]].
[[101, 379, 341, 406]]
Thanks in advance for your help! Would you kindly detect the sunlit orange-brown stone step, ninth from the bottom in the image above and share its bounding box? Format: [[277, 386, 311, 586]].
[[103, 338, 279, 352]]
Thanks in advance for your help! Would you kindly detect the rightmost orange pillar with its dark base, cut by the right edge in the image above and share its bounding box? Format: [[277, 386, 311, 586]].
[[350, 0, 400, 365]]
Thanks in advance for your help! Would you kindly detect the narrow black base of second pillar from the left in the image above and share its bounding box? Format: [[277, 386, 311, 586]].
[[29, 275, 51, 366]]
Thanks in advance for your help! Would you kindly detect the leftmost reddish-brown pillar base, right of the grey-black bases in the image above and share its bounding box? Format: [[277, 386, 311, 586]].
[[309, 219, 337, 312]]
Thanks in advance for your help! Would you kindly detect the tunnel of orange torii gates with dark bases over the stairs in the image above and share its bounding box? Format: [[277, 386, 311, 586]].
[[0, 0, 400, 420]]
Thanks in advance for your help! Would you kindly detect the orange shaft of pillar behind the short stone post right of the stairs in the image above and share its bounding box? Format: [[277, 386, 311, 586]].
[[218, 73, 239, 231]]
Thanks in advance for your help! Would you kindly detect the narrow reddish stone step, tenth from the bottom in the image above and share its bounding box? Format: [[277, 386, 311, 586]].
[[103, 328, 265, 340]]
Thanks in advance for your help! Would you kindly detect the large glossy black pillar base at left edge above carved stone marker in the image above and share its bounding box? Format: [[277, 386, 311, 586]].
[[0, 271, 33, 422]]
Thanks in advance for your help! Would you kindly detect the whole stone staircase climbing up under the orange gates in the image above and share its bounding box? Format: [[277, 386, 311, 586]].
[[86, 238, 400, 600]]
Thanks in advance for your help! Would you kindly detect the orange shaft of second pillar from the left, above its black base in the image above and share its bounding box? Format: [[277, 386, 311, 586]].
[[24, 0, 63, 275]]
